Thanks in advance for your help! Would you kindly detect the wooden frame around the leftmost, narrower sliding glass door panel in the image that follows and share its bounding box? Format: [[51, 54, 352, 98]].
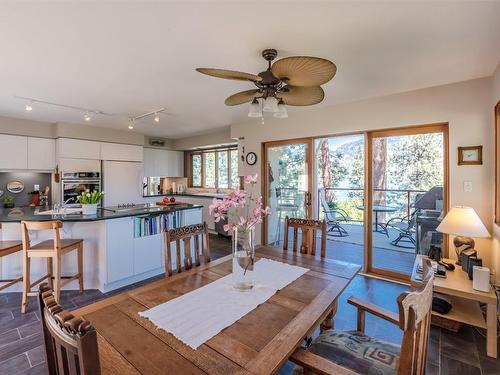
[[261, 137, 314, 245]]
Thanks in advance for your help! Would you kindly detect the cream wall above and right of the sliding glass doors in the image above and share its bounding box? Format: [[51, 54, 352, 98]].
[[231, 78, 493, 274]]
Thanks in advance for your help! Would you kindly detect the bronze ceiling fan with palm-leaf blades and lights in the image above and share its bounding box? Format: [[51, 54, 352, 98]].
[[196, 49, 337, 118]]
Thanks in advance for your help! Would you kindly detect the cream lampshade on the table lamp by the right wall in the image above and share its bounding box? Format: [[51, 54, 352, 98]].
[[436, 206, 490, 237]]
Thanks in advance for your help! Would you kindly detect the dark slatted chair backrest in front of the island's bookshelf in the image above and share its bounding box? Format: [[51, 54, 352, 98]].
[[163, 223, 210, 276]]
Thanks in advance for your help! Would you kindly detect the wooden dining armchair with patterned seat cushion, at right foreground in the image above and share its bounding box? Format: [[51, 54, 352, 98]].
[[291, 259, 434, 375]]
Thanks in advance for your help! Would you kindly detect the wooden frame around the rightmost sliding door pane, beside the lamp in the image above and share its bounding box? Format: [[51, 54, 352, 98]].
[[363, 122, 450, 280]]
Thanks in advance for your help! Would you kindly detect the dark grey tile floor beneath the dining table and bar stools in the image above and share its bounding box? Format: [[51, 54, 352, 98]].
[[0, 236, 500, 375]]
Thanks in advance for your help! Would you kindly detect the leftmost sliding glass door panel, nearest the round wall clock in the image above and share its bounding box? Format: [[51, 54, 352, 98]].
[[264, 139, 312, 246]]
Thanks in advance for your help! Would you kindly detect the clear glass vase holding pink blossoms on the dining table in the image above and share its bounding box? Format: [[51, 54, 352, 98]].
[[233, 228, 255, 291]]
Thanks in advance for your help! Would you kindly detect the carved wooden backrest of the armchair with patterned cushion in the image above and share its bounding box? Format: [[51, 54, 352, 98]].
[[398, 259, 434, 375]]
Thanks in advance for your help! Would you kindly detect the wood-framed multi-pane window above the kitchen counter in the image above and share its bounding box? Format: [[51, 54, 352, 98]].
[[190, 148, 239, 189]]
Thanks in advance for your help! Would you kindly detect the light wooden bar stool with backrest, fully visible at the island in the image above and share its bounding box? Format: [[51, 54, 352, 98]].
[[21, 221, 83, 313]]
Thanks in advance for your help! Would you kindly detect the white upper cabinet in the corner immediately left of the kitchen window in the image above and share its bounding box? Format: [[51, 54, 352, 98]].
[[144, 148, 184, 177]]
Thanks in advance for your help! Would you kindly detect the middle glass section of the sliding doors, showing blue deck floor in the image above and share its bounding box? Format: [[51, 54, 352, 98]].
[[313, 134, 365, 266]]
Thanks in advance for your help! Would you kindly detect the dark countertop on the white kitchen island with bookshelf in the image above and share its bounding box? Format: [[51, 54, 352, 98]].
[[0, 203, 203, 223]]
